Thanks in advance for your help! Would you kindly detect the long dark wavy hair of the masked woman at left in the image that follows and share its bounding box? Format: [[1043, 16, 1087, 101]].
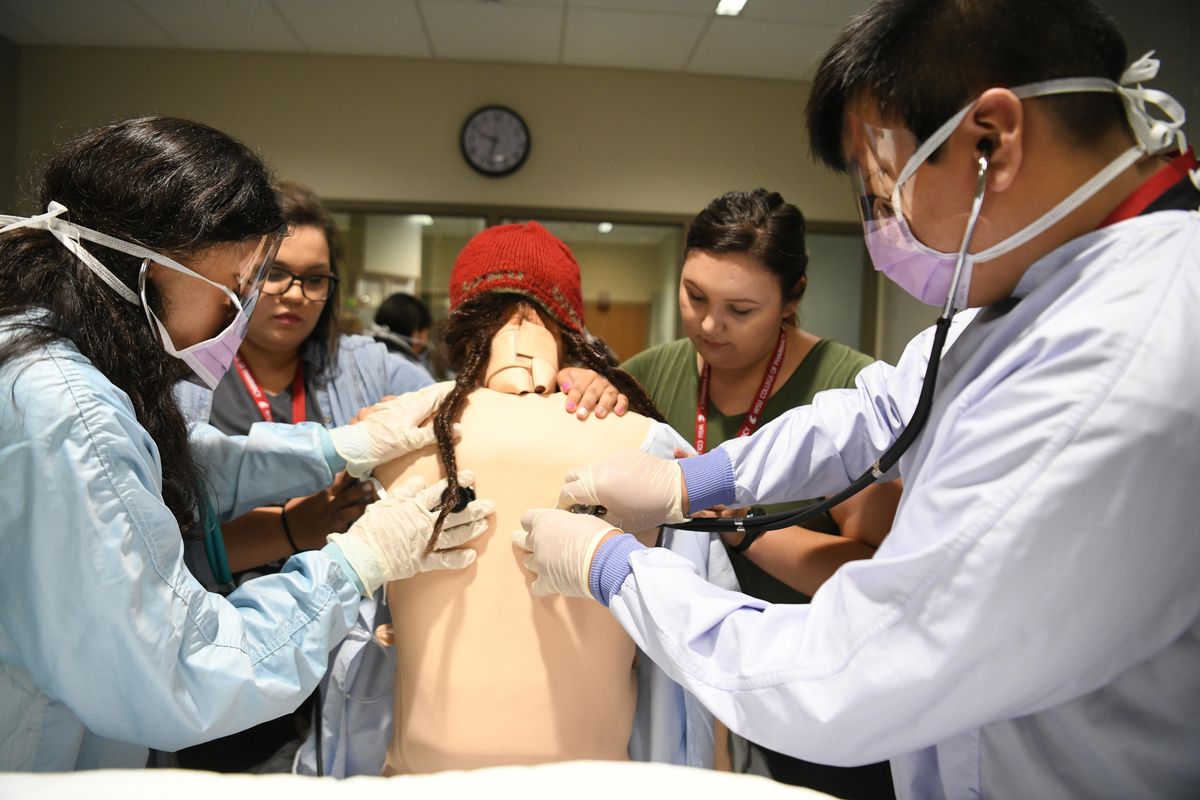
[[0, 116, 283, 536]]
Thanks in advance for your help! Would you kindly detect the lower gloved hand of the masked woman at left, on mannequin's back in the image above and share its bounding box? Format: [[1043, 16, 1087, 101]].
[[329, 469, 496, 595]]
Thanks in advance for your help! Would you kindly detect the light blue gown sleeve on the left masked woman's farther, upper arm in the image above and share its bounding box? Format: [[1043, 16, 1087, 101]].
[[190, 422, 334, 522]]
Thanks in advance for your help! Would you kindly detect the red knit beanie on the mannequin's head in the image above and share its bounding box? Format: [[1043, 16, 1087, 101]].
[[450, 222, 583, 333]]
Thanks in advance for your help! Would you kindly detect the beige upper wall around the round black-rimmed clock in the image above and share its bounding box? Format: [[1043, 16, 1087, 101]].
[[7, 47, 854, 219]]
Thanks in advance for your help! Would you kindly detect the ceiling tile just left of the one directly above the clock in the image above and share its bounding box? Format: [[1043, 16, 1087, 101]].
[[275, 0, 433, 58]]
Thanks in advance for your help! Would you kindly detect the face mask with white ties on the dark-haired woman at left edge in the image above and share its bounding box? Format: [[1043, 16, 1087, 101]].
[[0, 200, 281, 389]]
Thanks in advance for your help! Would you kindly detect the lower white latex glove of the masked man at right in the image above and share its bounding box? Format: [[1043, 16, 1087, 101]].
[[512, 509, 620, 597]]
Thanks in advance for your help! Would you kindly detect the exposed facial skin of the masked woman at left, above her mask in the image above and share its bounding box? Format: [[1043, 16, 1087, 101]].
[[148, 239, 259, 349]]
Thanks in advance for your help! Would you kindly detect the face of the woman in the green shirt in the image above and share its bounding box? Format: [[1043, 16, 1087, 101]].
[[679, 251, 799, 369]]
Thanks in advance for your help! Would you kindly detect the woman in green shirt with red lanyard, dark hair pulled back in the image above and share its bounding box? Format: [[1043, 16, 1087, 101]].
[[623, 188, 900, 798]]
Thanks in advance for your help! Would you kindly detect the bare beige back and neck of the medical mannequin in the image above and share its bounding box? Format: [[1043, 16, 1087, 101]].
[[376, 303, 656, 774]]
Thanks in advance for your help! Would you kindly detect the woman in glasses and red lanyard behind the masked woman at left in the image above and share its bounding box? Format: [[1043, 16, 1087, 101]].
[[166, 182, 433, 771]]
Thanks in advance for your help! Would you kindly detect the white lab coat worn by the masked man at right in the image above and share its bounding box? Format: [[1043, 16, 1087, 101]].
[[611, 211, 1200, 798]]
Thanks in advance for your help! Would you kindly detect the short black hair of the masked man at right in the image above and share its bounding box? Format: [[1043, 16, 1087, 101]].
[[806, 0, 1126, 172]]
